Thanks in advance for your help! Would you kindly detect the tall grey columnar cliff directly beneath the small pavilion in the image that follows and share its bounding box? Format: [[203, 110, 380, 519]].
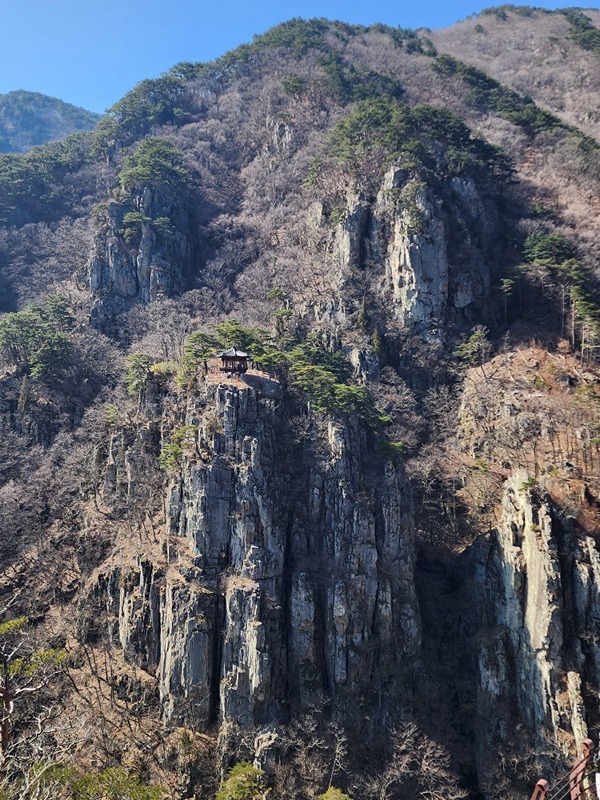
[[96, 379, 420, 740]]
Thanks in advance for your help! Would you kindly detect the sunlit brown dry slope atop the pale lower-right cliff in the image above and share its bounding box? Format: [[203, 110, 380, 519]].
[[446, 346, 600, 536]]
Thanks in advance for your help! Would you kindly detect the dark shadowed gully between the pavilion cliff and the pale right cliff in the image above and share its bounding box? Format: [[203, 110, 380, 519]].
[[415, 533, 544, 797]]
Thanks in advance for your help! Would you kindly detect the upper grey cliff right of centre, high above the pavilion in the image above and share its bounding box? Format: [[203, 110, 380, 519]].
[[329, 168, 498, 337]]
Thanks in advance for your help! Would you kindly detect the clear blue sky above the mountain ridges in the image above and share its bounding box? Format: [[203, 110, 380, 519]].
[[0, 0, 598, 112]]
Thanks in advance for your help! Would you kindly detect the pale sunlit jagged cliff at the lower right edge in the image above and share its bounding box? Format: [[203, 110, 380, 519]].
[[471, 472, 600, 776]]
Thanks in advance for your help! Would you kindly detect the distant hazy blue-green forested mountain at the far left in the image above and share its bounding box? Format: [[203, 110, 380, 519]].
[[0, 90, 100, 153]]
